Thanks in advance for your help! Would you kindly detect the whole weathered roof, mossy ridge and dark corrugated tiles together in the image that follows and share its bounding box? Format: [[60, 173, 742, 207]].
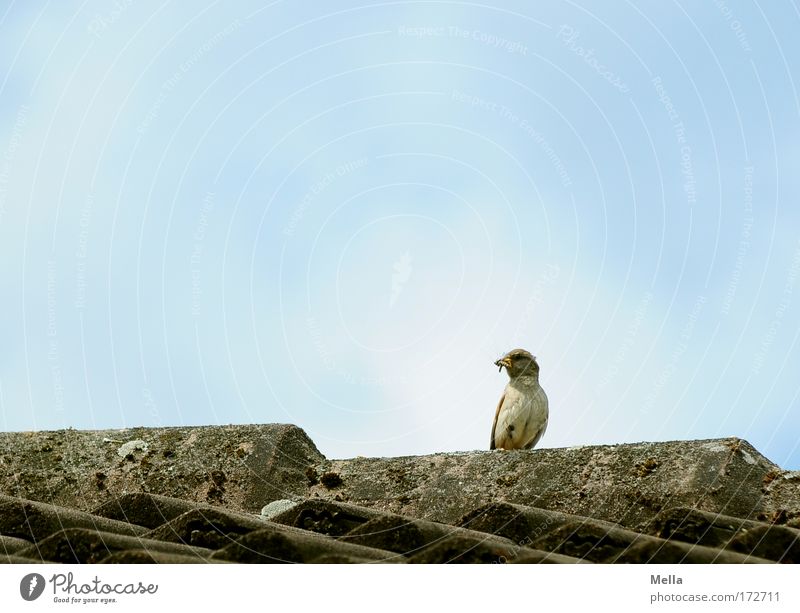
[[0, 424, 800, 563]]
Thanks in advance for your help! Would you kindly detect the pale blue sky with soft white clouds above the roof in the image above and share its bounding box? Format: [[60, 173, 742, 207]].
[[0, 0, 800, 469]]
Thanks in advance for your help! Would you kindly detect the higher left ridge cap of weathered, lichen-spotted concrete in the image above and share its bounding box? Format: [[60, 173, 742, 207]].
[[0, 424, 324, 512]]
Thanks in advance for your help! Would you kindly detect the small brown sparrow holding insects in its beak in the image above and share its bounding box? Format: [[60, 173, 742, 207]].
[[489, 349, 549, 449]]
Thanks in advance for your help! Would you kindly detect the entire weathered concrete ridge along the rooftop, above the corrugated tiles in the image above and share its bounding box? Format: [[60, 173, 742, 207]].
[[0, 424, 800, 528]]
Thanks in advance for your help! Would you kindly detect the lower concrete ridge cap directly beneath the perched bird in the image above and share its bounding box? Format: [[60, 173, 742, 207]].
[[310, 438, 788, 527]]
